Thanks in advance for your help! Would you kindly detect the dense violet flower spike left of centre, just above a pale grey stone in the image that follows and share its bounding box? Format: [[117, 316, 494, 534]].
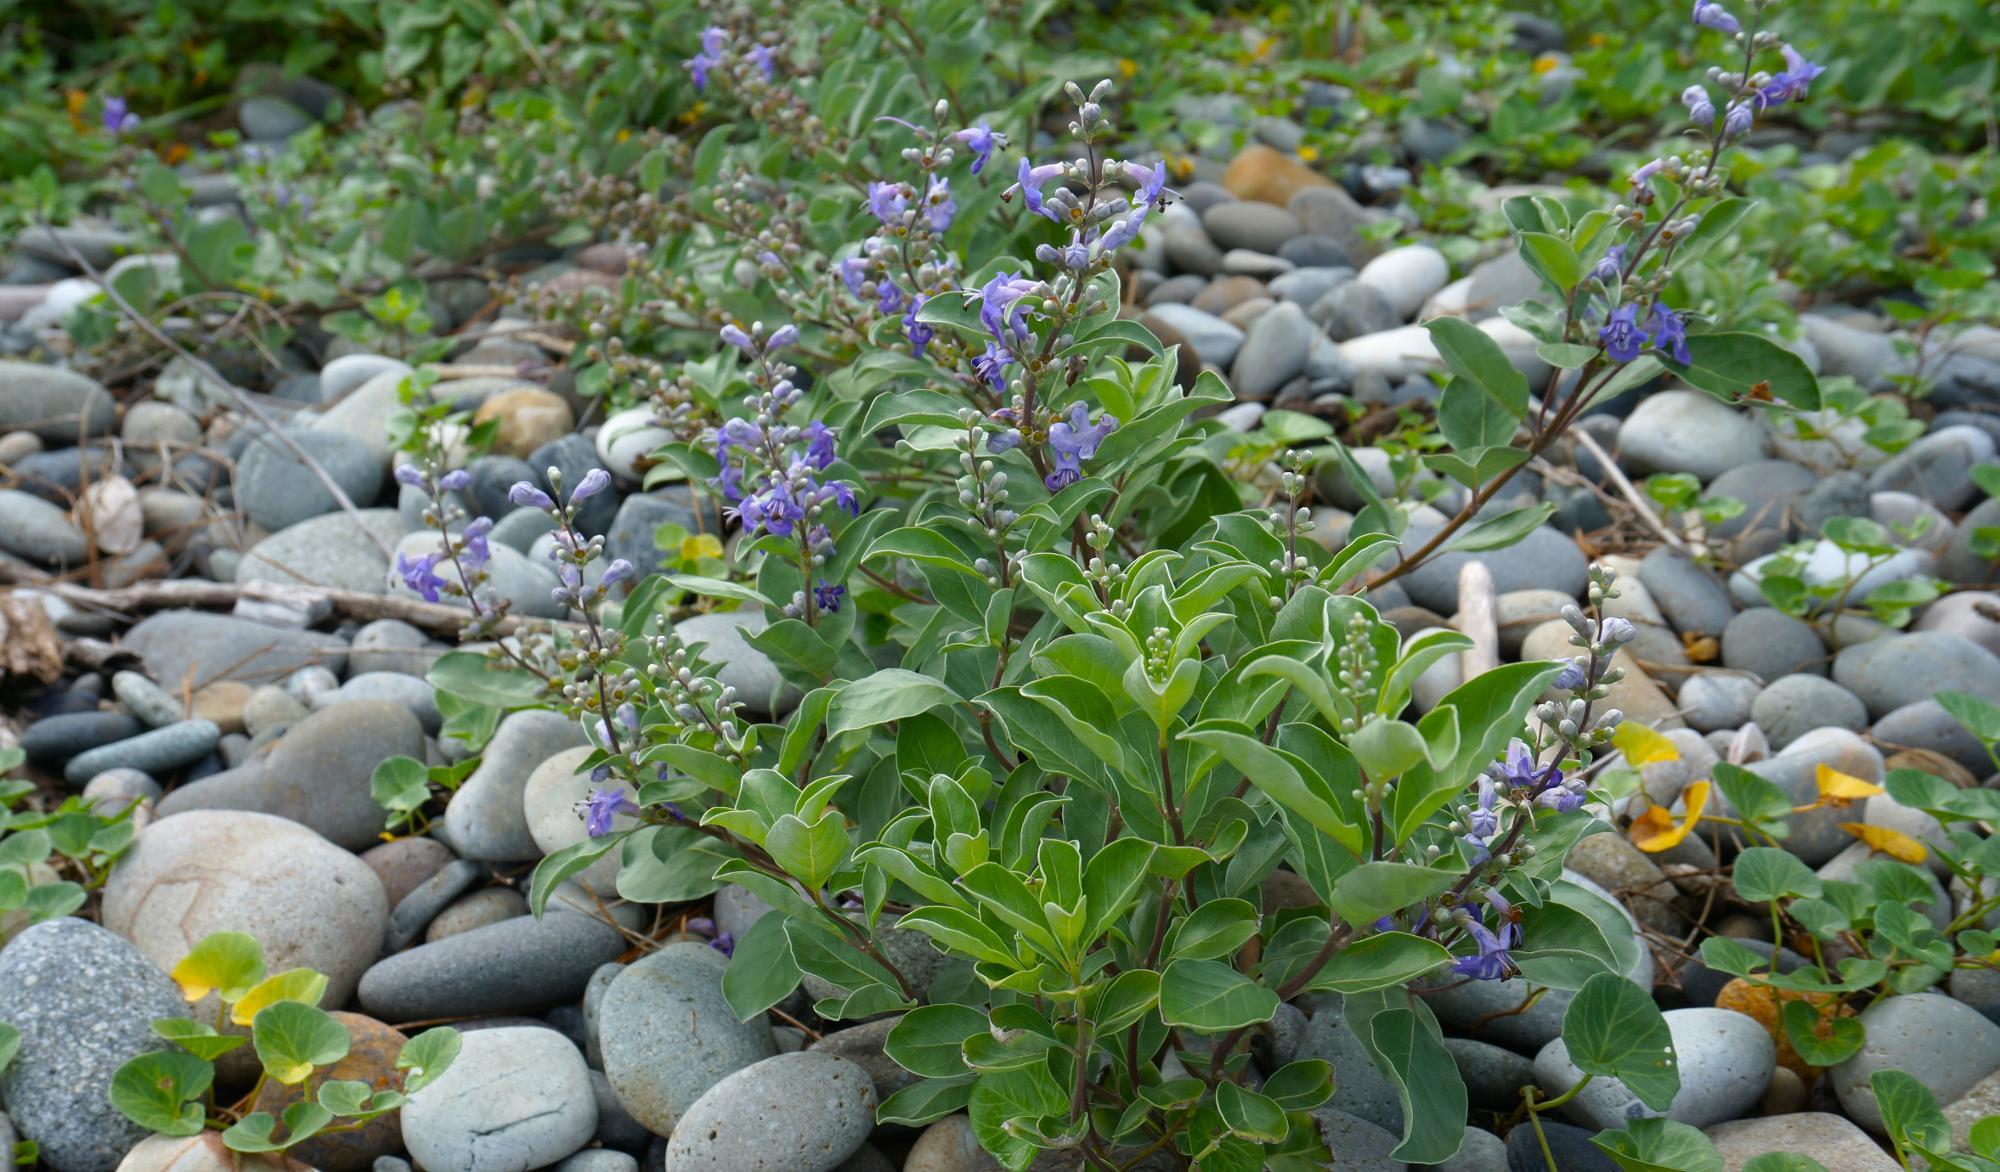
[[710, 322, 860, 622]]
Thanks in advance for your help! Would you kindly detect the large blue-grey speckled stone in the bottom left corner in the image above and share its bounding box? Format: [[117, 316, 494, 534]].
[[0, 918, 186, 1172]]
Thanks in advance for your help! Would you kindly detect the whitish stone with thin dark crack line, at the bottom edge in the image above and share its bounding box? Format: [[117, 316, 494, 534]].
[[402, 1026, 598, 1172]]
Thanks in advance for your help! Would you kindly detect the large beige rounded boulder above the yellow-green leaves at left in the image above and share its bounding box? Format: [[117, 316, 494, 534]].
[[104, 810, 388, 1008]]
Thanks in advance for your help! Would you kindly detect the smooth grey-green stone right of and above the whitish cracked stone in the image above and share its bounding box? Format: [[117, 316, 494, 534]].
[[598, 940, 772, 1136]]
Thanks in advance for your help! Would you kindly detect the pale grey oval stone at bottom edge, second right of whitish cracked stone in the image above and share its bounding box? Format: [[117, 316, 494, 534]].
[[666, 1050, 876, 1172]]
